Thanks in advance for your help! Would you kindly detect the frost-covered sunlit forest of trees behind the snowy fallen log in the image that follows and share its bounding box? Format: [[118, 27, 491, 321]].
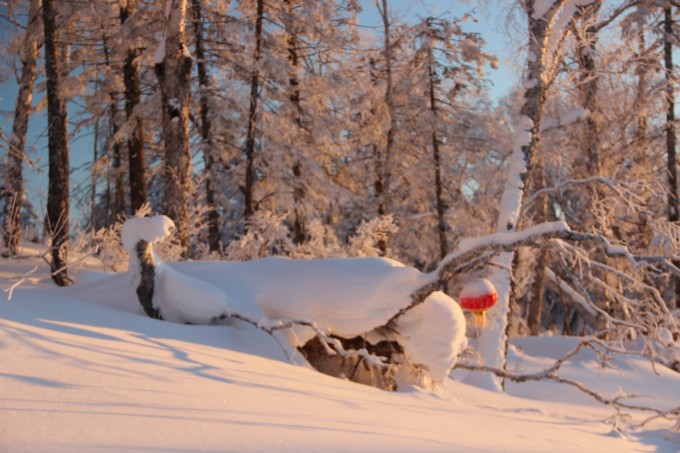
[[0, 0, 680, 388]]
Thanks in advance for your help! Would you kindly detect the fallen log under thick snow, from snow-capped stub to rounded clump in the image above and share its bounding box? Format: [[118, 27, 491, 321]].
[[121, 216, 466, 389]]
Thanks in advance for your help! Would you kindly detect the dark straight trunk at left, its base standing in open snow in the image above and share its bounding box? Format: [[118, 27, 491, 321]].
[[43, 0, 71, 286]]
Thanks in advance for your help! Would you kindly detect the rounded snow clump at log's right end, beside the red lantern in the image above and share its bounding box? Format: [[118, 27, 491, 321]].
[[396, 291, 467, 382]]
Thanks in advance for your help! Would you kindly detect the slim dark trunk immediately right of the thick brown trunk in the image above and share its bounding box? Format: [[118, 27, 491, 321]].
[[192, 0, 220, 252]]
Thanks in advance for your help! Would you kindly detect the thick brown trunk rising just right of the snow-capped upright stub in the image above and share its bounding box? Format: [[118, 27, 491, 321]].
[[155, 0, 192, 251]]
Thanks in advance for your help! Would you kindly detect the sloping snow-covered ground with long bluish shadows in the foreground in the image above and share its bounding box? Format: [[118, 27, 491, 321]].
[[0, 244, 680, 452]]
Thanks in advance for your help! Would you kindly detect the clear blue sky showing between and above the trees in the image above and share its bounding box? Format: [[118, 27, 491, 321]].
[[0, 0, 516, 226]]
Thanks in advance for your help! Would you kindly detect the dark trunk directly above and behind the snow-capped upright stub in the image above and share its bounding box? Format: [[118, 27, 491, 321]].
[[120, 0, 147, 214]]
